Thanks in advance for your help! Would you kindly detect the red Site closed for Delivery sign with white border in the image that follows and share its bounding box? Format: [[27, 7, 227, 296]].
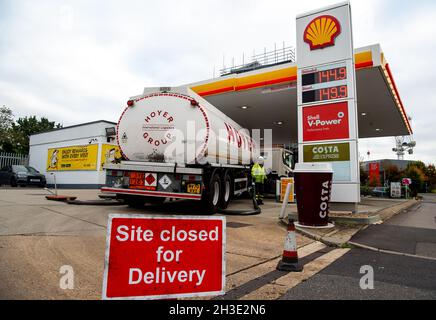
[[103, 215, 226, 299]]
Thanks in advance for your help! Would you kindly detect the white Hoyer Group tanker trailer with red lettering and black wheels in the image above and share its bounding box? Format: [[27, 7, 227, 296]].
[[101, 87, 260, 212]]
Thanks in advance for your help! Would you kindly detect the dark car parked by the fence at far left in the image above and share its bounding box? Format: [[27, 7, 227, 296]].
[[0, 165, 47, 188]]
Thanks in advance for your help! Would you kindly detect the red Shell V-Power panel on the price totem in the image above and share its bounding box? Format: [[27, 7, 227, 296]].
[[303, 102, 350, 141]]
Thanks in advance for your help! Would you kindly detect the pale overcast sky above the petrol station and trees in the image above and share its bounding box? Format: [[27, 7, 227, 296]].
[[0, 0, 436, 163]]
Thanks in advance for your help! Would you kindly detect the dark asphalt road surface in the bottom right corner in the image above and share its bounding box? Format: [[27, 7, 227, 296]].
[[281, 249, 436, 300]]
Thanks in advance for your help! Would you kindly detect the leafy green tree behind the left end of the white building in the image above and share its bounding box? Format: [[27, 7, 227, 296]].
[[10, 116, 62, 154]]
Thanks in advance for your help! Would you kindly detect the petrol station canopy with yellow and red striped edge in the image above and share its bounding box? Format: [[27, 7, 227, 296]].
[[189, 45, 412, 144]]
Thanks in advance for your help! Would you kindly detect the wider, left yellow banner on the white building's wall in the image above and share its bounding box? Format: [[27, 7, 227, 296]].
[[47, 144, 98, 171]]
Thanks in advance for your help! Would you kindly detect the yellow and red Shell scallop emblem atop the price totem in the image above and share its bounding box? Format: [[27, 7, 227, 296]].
[[304, 15, 341, 50]]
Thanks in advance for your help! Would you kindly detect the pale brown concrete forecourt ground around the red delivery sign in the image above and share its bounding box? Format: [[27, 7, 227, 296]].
[[0, 188, 313, 300]]
